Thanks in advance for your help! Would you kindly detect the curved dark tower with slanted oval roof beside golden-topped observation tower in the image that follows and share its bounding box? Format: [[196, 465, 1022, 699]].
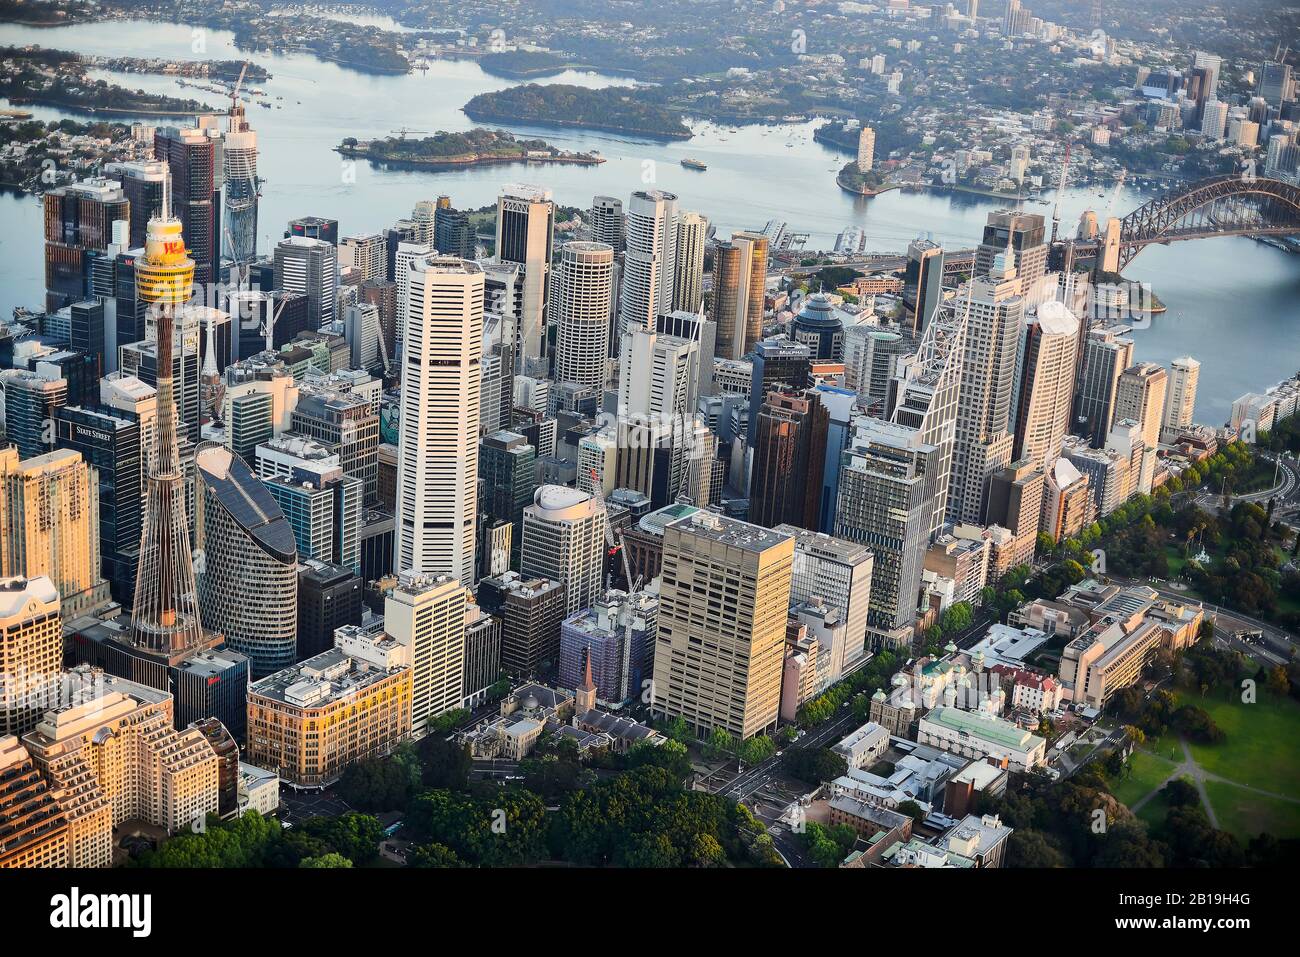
[[195, 445, 298, 677]]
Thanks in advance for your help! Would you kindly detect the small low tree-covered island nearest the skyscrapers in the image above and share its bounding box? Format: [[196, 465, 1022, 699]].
[[334, 126, 605, 170]]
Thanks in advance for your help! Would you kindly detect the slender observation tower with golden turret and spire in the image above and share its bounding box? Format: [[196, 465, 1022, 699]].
[[131, 167, 203, 654]]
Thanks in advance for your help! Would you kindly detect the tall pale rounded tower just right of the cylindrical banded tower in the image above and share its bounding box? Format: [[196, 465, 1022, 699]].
[[619, 190, 679, 335]]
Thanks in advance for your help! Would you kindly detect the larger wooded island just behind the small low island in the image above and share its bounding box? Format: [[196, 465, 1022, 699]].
[[464, 83, 690, 139]]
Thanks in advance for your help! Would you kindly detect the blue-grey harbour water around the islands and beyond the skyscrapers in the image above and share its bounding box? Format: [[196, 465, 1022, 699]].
[[0, 21, 1300, 424]]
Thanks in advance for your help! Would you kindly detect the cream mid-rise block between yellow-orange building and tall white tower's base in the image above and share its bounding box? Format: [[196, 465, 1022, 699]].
[[384, 572, 469, 733]]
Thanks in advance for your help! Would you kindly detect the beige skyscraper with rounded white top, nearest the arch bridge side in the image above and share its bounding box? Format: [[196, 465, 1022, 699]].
[[1013, 300, 1079, 469]]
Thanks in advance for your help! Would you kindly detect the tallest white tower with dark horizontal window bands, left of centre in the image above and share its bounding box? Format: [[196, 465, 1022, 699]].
[[395, 256, 484, 586]]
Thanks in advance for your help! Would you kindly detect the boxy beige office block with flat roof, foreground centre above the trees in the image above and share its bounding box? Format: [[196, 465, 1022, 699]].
[[650, 511, 794, 739]]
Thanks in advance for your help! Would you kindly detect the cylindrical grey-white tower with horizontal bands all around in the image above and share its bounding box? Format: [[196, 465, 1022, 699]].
[[551, 242, 614, 389]]
